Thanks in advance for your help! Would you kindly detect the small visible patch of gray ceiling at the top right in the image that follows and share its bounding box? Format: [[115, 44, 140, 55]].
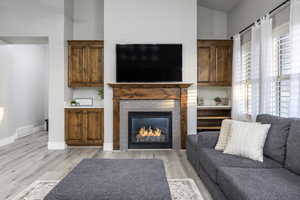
[[198, 0, 241, 12]]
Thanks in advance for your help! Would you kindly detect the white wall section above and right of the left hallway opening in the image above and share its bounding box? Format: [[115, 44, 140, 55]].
[[0, 0, 65, 148]]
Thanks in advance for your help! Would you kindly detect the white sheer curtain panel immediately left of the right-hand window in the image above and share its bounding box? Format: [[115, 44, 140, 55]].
[[260, 15, 275, 114]]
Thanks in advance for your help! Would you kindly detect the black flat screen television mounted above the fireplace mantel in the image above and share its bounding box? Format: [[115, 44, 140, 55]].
[[117, 44, 182, 82]]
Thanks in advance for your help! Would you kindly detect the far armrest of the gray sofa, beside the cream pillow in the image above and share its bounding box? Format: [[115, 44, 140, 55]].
[[198, 131, 220, 149]]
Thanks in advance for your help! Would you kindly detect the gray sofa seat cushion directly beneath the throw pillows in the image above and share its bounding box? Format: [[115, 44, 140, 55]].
[[198, 148, 281, 182]]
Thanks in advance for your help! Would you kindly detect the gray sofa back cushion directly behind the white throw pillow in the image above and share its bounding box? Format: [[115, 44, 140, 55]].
[[256, 115, 293, 164]]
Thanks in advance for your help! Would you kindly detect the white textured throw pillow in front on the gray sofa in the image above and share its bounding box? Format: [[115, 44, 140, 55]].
[[224, 121, 271, 162]]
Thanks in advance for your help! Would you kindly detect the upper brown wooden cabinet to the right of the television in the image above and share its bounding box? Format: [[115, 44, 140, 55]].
[[198, 40, 232, 86]]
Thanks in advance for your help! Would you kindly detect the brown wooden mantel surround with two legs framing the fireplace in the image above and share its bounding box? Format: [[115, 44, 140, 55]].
[[108, 83, 192, 150]]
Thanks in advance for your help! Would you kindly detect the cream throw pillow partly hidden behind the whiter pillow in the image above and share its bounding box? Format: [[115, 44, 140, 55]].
[[215, 119, 233, 151]]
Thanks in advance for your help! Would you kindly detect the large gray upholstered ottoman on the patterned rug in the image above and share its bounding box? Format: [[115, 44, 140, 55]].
[[45, 159, 171, 200]]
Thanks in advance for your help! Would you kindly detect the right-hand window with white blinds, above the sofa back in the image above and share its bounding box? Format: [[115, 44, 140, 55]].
[[272, 26, 291, 117]]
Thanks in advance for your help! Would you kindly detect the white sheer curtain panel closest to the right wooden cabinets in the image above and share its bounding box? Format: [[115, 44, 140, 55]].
[[232, 34, 243, 120]]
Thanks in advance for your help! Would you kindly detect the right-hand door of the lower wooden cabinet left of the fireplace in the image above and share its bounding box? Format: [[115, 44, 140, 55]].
[[86, 109, 104, 146]]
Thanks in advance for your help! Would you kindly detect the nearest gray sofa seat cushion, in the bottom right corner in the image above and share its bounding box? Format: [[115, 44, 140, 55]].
[[217, 167, 300, 200]]
